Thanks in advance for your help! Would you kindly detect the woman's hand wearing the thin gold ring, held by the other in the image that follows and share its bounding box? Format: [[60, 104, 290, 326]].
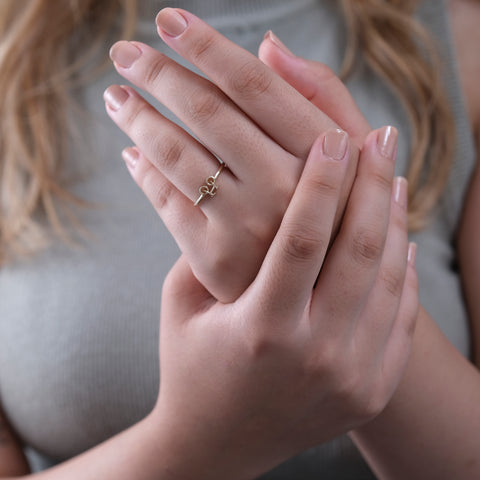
[[105, 9, 368, 302]]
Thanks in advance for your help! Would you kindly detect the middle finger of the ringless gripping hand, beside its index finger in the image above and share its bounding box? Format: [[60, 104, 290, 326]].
[[312, 127, 397, 338]]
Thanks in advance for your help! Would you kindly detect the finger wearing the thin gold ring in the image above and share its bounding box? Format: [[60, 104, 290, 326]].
[[104, 85, 236, 218]]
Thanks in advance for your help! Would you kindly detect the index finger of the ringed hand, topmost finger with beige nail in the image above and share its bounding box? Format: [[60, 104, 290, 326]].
[[157, 8, 355, 159]]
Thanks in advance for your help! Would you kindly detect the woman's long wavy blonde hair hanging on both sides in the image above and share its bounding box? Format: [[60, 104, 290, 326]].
[[0, 0, 462, 265]]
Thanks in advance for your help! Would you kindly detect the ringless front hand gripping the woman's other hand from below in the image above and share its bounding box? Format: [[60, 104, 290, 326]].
[[153, 130, 418, 479]]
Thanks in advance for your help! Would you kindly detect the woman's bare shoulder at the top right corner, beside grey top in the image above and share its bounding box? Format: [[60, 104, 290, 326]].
[[448, 0, 480, 142]]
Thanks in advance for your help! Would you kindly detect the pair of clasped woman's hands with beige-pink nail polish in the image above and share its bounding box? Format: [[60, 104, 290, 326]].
[[105, 8, 418, 479]]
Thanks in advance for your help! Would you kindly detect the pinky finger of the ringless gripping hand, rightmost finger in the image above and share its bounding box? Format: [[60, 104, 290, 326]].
[[383, 243, 420, 393]]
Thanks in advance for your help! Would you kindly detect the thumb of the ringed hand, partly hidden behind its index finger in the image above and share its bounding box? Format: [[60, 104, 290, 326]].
[[258, 32, 371, 145]]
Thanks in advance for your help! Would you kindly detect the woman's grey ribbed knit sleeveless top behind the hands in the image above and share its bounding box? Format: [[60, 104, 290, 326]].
[[0, 0, 474, 480]]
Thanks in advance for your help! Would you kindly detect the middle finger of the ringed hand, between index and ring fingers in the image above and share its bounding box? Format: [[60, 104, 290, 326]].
[[110, 41, 296, 183]]
